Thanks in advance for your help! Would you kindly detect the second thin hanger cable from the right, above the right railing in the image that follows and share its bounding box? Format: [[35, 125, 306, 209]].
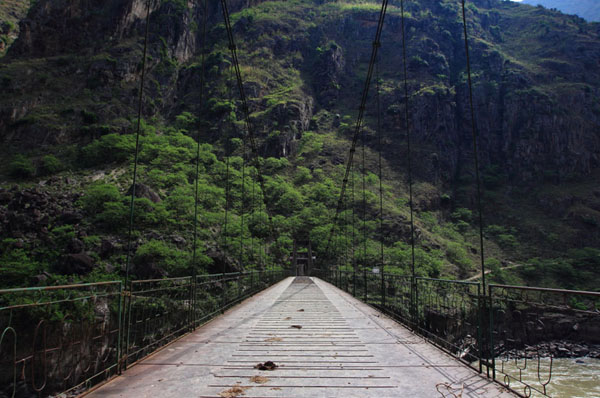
[[400, 0, 416, 311]]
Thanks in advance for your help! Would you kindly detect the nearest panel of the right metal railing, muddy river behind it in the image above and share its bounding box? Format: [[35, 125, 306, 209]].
[[488, 285, 600, 396]]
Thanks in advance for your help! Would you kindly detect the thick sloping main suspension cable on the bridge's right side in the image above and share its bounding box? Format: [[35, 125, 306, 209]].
[[325, 0, 388, 266]]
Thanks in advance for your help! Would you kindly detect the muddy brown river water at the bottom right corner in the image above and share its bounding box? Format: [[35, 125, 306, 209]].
[[496, 358, 600, 398]]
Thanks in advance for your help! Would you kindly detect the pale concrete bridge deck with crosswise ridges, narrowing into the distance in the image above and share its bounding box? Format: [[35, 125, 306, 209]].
[[88, 278, 515, 398]]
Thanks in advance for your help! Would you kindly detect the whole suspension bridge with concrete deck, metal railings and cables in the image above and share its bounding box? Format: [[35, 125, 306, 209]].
[[0, 0, 600, 398]]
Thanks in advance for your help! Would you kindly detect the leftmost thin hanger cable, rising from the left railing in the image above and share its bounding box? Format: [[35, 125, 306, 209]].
[[124, 0, 150, 289]]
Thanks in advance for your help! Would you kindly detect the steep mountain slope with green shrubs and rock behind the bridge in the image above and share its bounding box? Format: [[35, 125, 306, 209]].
[[0, 0, 600, 290]]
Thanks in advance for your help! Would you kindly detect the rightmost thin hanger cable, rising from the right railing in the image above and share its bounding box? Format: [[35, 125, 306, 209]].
[[461, 0, 485, 292]]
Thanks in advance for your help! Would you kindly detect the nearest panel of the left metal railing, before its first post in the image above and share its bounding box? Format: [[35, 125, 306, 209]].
[[0, 282, 123, 397]]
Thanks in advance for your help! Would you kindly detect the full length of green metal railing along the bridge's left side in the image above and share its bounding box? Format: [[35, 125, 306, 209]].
[[0, 270, 288, 397]]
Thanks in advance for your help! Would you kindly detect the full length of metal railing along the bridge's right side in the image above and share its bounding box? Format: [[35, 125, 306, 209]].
[[318, 269, 600, 397]]
